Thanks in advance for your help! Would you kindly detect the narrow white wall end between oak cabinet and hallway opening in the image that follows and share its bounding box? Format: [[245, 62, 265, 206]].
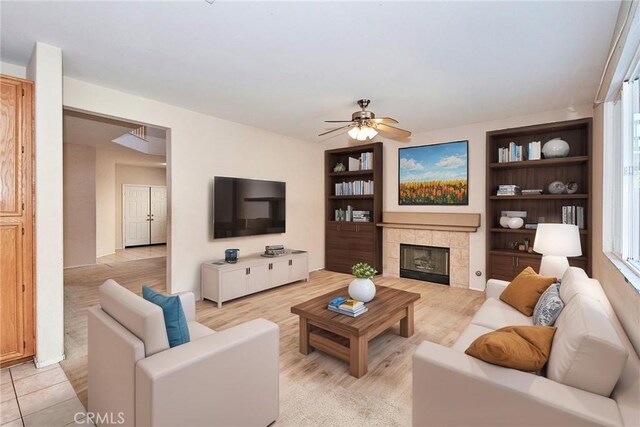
[[27, 43, 64, 367]]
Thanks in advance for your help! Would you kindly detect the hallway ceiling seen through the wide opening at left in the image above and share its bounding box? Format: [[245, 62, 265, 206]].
[[63, 109, 166, 167]]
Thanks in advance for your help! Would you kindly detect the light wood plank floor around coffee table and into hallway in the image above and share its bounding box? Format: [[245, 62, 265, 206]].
[[61, 258, 484, 425]]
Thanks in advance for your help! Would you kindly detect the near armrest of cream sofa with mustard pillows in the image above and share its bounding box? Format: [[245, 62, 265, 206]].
[[413, 341, 622, 426]]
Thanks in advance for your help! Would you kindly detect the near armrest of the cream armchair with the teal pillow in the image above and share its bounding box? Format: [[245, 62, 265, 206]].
[[136, 319, 279, 426]]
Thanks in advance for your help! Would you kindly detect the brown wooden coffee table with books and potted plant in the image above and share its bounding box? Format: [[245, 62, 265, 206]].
[[291, 286, 420, 378]]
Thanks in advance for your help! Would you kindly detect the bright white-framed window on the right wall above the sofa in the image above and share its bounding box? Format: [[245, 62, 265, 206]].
[[611, 73, 640, 275]]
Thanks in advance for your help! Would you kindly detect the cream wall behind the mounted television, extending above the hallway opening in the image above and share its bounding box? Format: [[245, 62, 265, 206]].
[[64, 78, 325, 296]]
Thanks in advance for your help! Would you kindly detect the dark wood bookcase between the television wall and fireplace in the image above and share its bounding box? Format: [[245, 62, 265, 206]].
[[325, 142, 383, 274]]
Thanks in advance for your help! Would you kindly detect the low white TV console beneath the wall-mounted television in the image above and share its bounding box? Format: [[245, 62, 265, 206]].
[[201, 250, 309, 307]]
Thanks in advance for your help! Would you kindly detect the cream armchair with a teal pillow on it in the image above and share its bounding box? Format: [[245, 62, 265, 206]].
[[88, 280, 279, 426]]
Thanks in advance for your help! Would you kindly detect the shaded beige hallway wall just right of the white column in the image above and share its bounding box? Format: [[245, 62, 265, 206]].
[[63, 144, 96, 268]]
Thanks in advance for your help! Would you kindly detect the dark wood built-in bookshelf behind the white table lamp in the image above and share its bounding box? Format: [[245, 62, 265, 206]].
[[486, 119, 592, 280]]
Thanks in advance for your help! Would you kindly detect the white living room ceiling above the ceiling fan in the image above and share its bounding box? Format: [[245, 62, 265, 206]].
[[0, 0, 620, 141]]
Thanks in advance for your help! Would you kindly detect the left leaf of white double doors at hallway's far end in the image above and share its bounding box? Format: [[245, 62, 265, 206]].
[[123, 185, 151, 247]]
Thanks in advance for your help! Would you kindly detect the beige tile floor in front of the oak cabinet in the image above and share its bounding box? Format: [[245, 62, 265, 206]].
[[0, 362, 93, 427]]
